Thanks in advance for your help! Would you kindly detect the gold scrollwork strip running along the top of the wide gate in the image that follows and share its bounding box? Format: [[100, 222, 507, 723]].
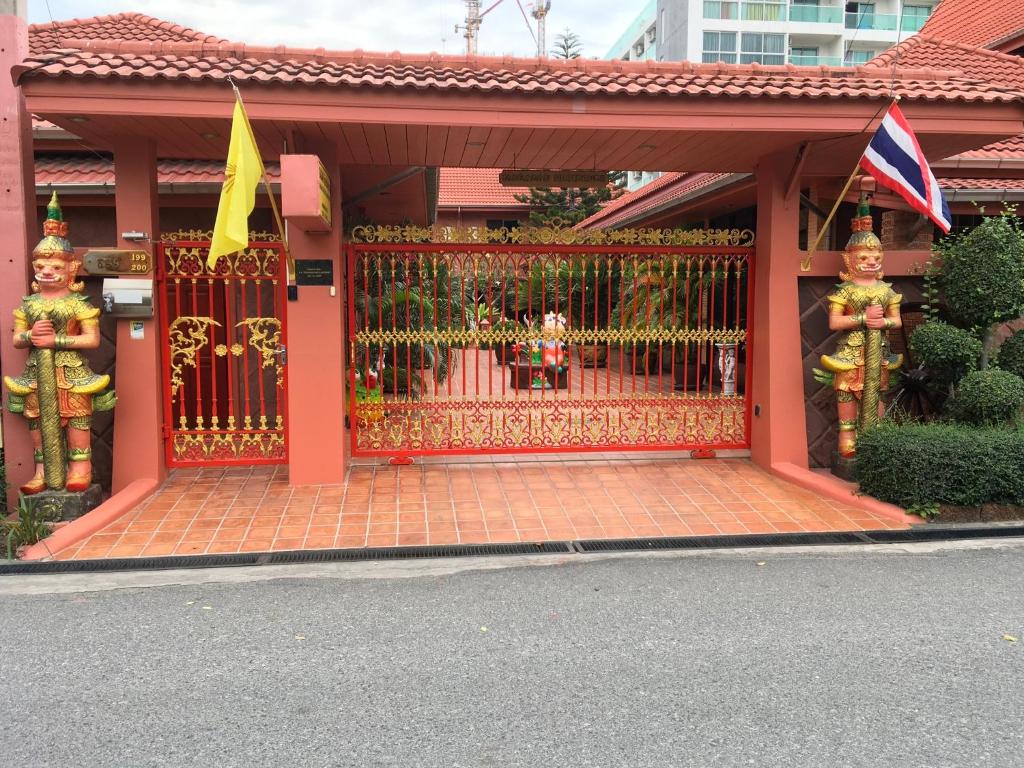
[[350, 224, 755, 248]]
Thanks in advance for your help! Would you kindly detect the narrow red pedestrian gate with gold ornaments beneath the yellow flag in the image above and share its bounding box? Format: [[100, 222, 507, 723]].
[[158, 240, 288, 467]]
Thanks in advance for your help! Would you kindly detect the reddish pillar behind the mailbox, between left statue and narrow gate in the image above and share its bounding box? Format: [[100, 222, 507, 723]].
[[113, 136, 167, 493]]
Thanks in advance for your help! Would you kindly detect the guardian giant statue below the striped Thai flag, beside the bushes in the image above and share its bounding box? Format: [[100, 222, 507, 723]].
[[821, 195, 903, 459]]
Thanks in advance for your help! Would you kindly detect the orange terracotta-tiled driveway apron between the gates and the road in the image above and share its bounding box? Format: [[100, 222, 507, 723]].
[[56, 459, 905, 559]]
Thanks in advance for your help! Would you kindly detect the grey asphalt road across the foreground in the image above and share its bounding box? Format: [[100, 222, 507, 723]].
[[0, 544, 1024, 768]]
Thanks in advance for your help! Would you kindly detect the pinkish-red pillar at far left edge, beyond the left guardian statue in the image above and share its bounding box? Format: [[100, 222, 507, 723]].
[[0, 0, 35, 512]]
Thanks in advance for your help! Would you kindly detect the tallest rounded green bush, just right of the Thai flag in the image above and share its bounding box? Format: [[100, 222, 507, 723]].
[[936, 215, 1024, 335]]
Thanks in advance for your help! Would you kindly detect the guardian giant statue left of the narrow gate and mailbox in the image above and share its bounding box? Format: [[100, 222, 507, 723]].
[[4, 193, 116, 496]]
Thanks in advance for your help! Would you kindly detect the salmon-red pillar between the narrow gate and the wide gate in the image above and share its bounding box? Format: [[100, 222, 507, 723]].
[[287, 143, 346, 485]]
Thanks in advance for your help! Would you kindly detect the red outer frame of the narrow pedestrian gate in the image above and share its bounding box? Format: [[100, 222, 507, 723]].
[[154, 239, 290, 469]]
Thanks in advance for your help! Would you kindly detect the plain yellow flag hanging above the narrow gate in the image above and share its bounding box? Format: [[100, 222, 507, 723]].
[[207, 95, 263, 269]]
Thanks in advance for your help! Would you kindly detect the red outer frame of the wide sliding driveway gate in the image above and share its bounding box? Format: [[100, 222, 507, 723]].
[[344, 234, 757, 463]]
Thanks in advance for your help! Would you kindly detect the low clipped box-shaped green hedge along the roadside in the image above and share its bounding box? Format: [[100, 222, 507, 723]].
[[854, 422, 1024, 509]]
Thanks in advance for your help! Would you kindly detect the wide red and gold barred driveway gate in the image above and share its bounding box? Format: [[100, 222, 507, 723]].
[[348, 226, 754, 457]]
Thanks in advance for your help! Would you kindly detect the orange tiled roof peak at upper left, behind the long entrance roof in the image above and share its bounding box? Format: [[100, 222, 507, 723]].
[[29, 13, 227, 54]]
